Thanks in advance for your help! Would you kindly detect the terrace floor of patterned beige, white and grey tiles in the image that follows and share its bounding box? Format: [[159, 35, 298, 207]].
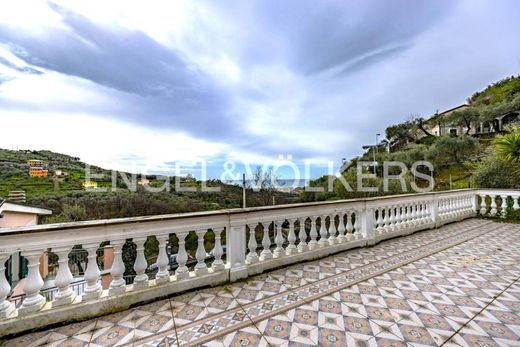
[[7, 219, 520, 346]]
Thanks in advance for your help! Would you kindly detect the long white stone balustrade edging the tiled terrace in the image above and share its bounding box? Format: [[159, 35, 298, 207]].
[[0, 189, 520, 336]]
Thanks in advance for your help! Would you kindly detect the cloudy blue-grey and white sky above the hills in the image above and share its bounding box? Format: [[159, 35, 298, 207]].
[[0, 0, 520, 177]]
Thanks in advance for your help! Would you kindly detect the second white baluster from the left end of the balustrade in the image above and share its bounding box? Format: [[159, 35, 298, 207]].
[[18, 250, 45, 316]]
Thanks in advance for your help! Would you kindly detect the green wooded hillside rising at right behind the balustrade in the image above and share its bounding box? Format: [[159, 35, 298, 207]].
[[301, 77, 520, 201]]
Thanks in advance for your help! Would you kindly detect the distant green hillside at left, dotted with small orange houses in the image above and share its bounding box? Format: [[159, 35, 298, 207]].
[[0, 149, 291, 223]]
